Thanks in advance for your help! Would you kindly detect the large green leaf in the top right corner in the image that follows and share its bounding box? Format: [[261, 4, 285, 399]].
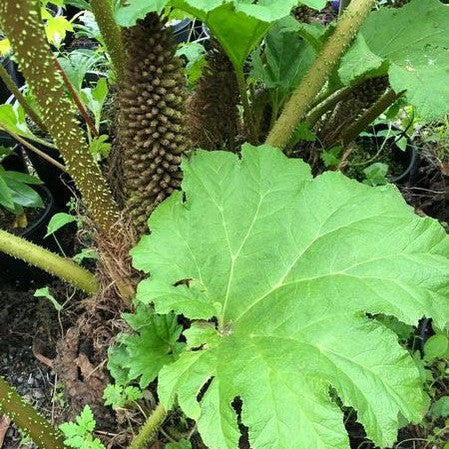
[[340, 0, 449, 118]]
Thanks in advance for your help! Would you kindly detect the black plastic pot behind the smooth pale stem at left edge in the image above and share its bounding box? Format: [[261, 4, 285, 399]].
[[0, 186, 57, 288]]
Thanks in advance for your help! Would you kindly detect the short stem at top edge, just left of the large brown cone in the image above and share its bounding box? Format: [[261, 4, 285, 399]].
[[90, 0, 125, 80]]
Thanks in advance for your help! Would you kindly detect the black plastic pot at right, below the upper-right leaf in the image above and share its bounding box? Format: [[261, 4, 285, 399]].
[[359, 123, 419, 184]]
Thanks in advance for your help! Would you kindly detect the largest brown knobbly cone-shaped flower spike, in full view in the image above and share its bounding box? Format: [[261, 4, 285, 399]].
[[119, 14, 188, 233]]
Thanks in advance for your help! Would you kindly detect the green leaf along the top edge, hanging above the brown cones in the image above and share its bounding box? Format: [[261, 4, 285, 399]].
[[116, 0, 326, 66]]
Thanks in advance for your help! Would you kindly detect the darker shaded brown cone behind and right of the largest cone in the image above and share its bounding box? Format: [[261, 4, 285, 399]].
[[188, 41, 241, 151]]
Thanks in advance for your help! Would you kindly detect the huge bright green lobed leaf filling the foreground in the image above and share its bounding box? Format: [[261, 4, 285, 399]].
[[133, 146, 449, 449]]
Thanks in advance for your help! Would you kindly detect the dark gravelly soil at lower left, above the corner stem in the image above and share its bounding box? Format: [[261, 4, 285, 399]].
[[0, 283, 70, 449]]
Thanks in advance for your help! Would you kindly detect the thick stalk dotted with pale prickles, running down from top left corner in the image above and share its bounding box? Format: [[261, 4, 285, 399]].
[[0, 0, 119, 232]]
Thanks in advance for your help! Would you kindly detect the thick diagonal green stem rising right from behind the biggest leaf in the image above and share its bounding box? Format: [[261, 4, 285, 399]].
[[267, 0, 376, 148]]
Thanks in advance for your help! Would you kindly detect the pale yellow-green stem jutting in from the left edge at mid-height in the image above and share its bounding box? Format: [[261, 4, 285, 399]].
[[0, 229, 98, 294]]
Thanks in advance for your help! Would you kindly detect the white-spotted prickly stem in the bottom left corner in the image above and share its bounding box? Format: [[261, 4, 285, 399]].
[[0, 376, 67, 449]]
